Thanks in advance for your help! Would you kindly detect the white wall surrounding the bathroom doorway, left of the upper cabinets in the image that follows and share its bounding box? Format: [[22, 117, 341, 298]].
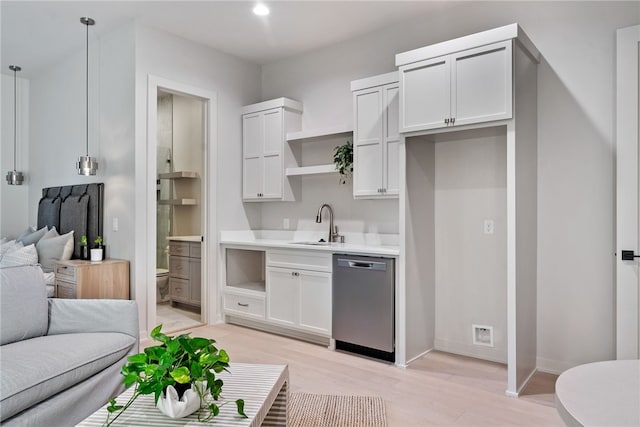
[[133, 26, 260, 331]]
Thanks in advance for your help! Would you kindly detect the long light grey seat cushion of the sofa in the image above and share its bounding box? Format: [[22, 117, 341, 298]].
[[0, 332, 136, 421]]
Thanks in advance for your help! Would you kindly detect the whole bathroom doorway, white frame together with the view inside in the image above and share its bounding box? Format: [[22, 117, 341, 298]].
[[146, 75, 219, 334]]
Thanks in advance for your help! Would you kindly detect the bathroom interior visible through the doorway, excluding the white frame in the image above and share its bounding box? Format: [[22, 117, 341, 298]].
[[156, 90, 206, 332]]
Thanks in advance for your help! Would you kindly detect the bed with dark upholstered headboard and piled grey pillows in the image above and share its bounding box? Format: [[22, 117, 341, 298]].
[[0, 183, 104, 297]]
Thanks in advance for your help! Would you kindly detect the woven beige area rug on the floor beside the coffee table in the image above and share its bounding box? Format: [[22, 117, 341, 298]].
[[289, 393, 387, 427]]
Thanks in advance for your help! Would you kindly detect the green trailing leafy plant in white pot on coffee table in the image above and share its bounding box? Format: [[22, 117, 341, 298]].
[[105, 325, 247, 426]]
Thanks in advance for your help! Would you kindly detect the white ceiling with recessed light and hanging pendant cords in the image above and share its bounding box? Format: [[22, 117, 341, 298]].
[[0, 0, 453, 77]]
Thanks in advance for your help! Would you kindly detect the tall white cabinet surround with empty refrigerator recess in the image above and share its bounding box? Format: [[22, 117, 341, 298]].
[[396, 24, 539, 396]]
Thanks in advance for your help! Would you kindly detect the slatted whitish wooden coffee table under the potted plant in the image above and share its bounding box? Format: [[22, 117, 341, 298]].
[[78, 363, 289, 427]]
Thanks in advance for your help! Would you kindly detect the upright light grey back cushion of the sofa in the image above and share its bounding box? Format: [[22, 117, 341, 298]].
[[0, 265, 49, 346]]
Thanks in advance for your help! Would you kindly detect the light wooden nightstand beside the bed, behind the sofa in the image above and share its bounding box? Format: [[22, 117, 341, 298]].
[[53, 259, 129, 299]]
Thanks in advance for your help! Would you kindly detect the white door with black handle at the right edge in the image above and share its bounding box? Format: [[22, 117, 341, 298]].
[[616, 25, 640, 359]]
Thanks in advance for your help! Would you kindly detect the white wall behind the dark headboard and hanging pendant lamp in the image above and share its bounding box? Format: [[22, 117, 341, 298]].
[[26, 22, 134, 261]]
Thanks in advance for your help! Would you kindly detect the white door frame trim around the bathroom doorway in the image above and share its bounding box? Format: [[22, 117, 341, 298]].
[[145, 74, 218, 331]]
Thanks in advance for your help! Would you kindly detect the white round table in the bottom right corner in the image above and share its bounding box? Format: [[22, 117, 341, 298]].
[[556, 360, 640, 427]]
